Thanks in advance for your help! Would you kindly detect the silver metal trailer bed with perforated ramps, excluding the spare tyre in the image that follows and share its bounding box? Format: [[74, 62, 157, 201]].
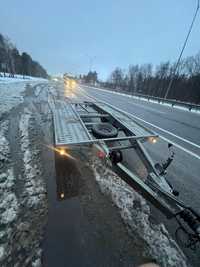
[[51, 100, 156, 146]]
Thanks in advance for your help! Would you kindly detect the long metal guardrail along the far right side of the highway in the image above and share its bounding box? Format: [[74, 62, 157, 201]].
[[85, 84, 200, 112]]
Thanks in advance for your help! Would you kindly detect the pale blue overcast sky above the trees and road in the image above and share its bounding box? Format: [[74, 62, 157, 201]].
[[0, 0, 200, 77]]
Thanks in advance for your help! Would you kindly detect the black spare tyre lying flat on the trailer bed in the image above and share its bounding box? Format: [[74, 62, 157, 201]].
[[92, 123, 118, 138]]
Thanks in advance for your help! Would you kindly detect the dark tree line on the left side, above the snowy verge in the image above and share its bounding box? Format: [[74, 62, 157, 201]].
[[0, 34, 48, 78]]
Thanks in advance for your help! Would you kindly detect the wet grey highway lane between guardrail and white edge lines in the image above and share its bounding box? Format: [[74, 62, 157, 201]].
[[82, 87, 200, 158]]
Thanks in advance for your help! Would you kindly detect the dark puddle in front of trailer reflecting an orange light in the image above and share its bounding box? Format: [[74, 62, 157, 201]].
[[43, 153, 85, 267]]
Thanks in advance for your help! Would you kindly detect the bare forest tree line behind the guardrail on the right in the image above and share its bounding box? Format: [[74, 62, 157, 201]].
[[102, 52, 200, 104]]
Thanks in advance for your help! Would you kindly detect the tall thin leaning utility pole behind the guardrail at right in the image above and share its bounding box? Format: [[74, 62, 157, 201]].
[[164, 0, 199, 99]]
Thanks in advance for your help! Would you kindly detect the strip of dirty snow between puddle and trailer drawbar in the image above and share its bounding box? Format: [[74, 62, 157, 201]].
[[92, 157, 187, 267]]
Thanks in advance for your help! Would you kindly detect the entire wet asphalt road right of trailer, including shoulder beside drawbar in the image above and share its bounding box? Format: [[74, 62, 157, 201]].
[[81, 86, 200, 212]]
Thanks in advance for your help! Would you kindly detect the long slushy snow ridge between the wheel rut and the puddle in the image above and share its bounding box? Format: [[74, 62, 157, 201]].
[[3, 108, 47, 267]]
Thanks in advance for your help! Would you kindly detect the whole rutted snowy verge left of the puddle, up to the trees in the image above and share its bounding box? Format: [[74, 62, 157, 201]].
[[0, 81, 47, 267]]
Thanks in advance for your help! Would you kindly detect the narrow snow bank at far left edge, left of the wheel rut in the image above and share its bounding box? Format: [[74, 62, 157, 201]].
[[0, 121, 19, 266]]
